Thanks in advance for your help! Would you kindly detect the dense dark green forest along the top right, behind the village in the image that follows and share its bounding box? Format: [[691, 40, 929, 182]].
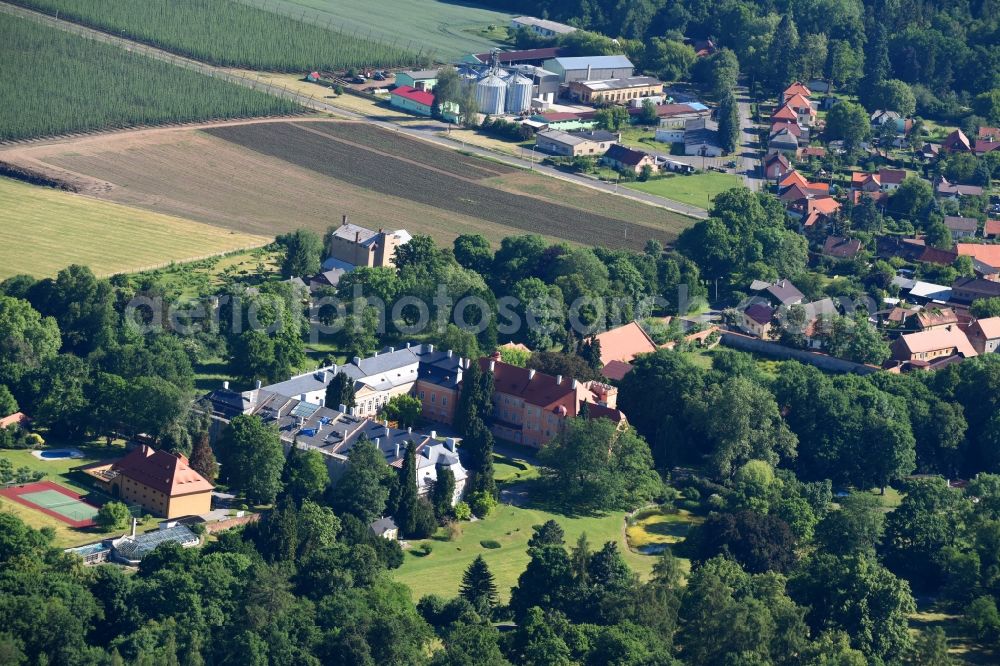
[[494, 0, 1000, 120]]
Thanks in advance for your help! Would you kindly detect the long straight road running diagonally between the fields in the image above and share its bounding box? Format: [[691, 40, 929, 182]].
[[0, 1, 708, 218]]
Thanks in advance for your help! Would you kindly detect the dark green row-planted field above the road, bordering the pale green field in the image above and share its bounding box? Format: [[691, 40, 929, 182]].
[[16, 0, 427, 72]]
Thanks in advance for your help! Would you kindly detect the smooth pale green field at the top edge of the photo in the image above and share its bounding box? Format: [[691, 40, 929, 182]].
[[247, 0, 514, 62]]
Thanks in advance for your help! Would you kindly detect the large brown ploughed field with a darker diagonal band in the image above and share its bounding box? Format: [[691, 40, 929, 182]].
[[0, 119, 693, 248]]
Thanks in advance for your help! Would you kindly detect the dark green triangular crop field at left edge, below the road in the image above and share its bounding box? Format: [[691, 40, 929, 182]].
[[0, 14, 299, 141]]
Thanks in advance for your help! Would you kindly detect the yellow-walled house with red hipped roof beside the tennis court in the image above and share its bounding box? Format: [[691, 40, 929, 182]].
[[79, 444, 215, 518]]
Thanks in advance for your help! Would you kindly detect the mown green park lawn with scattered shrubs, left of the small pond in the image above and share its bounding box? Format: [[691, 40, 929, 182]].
[[394, 506, 656, 601]]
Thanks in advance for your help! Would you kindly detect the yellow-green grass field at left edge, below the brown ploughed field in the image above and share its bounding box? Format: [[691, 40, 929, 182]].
[[0, 178, 271, 279]]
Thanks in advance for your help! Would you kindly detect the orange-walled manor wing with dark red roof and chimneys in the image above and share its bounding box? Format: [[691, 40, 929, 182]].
[[480, 354, 627, 448]]
